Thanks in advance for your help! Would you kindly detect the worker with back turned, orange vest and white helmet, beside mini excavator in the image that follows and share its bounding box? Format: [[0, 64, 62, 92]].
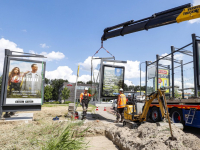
[[114, 88, 126, 123]]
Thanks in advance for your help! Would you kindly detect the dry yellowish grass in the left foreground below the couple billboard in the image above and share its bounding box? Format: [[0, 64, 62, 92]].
[[0, 104, 90, 150]]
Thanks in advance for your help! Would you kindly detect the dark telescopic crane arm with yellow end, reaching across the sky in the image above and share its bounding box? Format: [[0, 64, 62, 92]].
[[101, 3, 200, 41]]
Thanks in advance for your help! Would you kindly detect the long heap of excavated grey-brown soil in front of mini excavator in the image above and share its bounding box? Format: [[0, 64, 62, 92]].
[[79, 121, 200, 150]]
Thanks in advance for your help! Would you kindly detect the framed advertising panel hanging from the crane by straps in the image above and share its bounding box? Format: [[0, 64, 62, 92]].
[[101, 65, 125, 97]]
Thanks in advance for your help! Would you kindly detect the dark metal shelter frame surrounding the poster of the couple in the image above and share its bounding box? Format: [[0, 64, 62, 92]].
[[0, 49, 46, 118]]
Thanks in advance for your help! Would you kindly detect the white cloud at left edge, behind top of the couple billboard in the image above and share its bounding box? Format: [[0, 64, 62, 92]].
[[0, 38, 23, 74]]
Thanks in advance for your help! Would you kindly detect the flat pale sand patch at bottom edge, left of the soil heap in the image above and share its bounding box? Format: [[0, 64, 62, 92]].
[[85, 136, 119, 150]]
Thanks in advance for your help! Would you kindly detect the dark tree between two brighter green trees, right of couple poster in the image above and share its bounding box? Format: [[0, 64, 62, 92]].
[[51, 79, 68, 100]]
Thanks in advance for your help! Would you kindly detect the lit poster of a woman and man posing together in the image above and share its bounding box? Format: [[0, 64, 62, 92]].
[[4, 58, 44, 105]]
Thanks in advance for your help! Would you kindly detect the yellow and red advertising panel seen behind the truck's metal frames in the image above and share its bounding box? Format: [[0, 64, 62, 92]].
[[155, 69, 169, 93]]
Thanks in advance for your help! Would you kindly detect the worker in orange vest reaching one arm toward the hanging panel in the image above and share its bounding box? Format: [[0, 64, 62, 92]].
[[80, 87, 96, 120]]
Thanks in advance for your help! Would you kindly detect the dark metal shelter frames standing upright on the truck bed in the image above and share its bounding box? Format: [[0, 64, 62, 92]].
[[145, 34, 200, 98]]
